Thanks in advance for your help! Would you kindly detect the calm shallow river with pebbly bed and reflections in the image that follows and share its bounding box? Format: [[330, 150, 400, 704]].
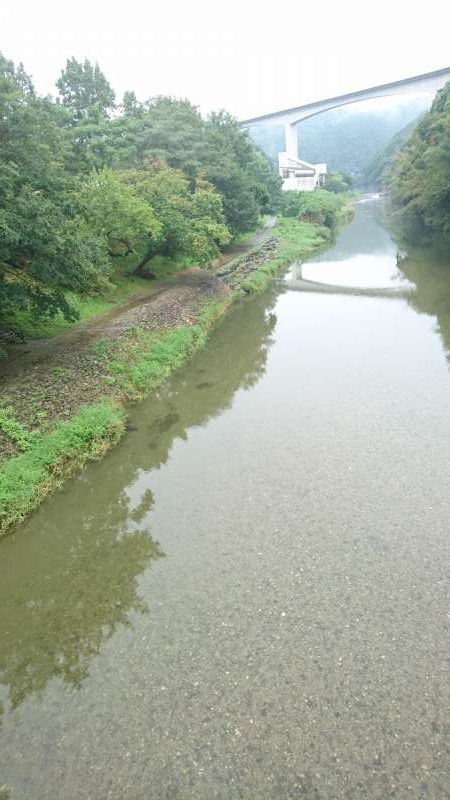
[[0, 202, 450, 800]]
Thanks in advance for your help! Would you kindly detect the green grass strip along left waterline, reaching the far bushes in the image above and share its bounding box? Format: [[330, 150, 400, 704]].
[[0, 208, 356, 534]]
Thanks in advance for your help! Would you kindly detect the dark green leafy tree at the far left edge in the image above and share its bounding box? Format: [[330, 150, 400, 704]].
[[0, 56, 108, 318]]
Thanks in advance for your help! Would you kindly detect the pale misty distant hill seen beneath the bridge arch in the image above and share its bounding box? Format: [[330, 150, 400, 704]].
[[250, 99, 426, 184]]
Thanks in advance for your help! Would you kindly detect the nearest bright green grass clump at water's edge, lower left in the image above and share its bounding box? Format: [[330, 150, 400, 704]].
[[0, 401, 125, 535]]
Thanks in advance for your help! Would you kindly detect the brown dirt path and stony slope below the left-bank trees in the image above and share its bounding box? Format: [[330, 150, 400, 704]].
[[0, 220, 273, 458]]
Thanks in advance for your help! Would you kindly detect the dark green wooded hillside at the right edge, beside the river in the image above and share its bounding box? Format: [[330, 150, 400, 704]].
[[388, 82, 450, 239]]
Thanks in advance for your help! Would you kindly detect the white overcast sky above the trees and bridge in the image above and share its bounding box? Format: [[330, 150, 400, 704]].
[[0, 0, 450, 118]]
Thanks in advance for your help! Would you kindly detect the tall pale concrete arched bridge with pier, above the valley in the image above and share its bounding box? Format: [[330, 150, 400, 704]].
[[241, 67, 450, 161]]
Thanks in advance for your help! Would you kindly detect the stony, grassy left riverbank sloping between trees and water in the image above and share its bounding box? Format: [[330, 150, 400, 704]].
[[0, 219, 331, 535]]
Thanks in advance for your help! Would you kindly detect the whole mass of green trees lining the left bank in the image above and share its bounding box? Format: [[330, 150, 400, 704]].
[[0, 54, 280, 322]]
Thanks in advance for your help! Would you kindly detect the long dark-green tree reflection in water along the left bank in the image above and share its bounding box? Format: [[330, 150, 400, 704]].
[[0, 290, 276, 718]]
